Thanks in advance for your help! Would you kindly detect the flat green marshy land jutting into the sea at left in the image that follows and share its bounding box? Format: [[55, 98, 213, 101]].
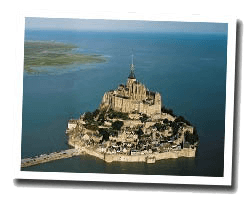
[[24, 41, 105, 73]]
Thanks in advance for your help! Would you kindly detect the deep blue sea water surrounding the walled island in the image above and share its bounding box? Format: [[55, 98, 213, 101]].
[[20, 30, 227, 177]]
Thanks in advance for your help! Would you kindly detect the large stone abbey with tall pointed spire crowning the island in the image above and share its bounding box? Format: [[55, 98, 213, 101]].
[[100, 54, 162, 116]]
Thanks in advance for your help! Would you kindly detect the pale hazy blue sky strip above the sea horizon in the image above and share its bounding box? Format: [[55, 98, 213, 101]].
[[25, 17, 228, 33]]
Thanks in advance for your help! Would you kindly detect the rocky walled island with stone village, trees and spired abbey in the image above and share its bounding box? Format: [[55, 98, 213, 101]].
[[66, 54, 199, 163]]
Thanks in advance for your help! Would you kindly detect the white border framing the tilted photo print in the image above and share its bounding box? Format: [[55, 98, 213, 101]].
[[12, 10, 236, 186]]
